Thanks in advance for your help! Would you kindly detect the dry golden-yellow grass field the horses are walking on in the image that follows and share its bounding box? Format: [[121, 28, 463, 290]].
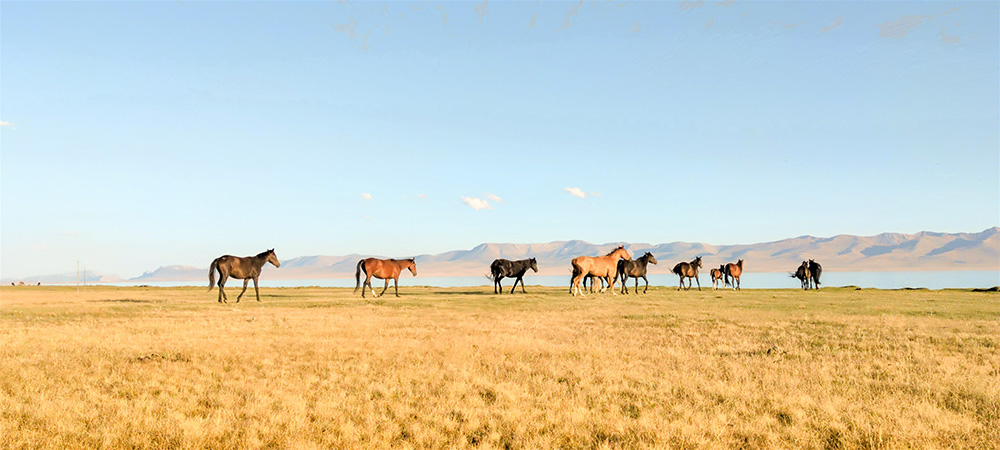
[[0, 286, 1000, 449]]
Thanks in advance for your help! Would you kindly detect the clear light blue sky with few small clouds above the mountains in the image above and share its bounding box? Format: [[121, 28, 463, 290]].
[[0, 0, 1000, 277]]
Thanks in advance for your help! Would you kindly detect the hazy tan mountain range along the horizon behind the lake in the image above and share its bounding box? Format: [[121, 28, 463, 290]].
[[0, 227, 1000, 284]]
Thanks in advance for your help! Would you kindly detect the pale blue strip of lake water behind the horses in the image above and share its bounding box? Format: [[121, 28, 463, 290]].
[[101, 270, 1000, 292]]
